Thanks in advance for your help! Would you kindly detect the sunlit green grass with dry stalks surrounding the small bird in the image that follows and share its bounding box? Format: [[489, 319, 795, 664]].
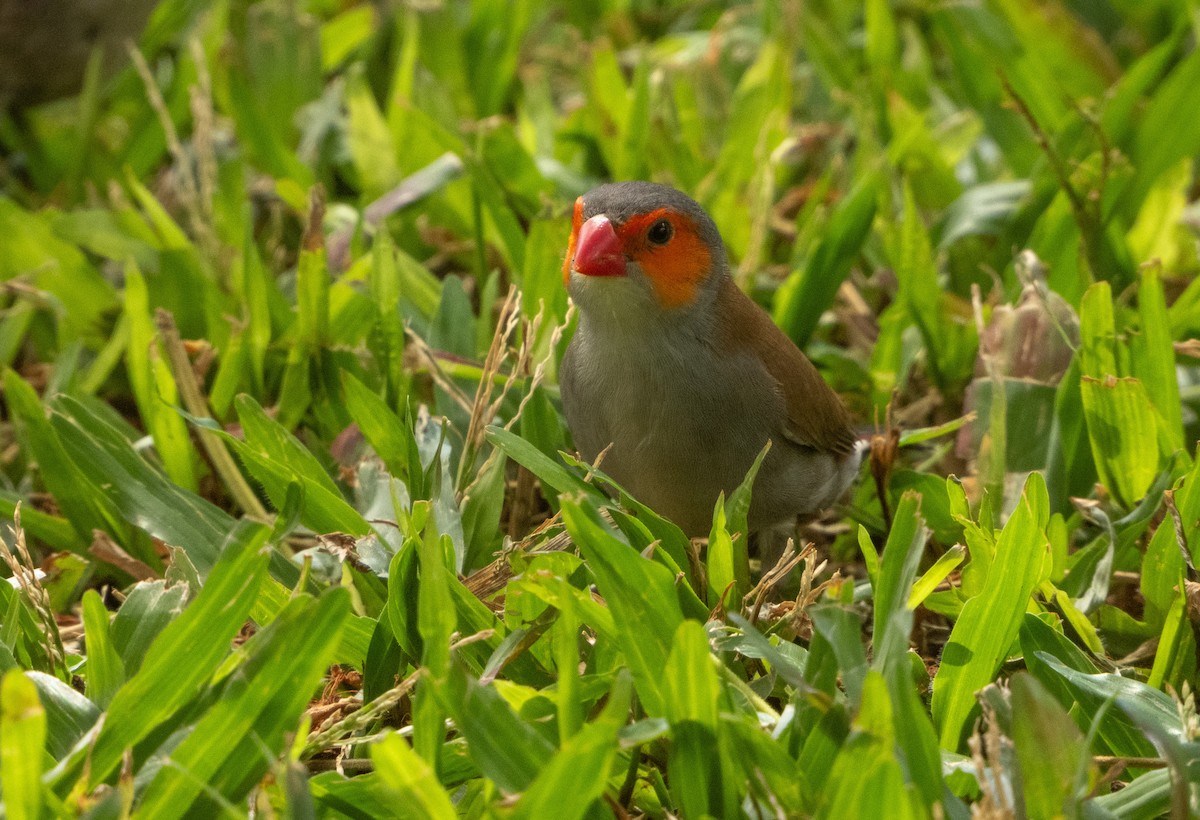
[[0, 0, 1200, 818]]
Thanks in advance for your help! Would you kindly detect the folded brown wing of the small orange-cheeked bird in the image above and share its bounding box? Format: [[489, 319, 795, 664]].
[[718, 276, 856, 454]]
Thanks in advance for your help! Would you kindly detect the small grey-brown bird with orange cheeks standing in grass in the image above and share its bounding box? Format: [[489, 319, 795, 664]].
[[559, 182, 863, 537]]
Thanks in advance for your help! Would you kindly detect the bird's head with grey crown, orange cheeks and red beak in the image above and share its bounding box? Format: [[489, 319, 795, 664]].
[[563, 182, 728, 318]]
